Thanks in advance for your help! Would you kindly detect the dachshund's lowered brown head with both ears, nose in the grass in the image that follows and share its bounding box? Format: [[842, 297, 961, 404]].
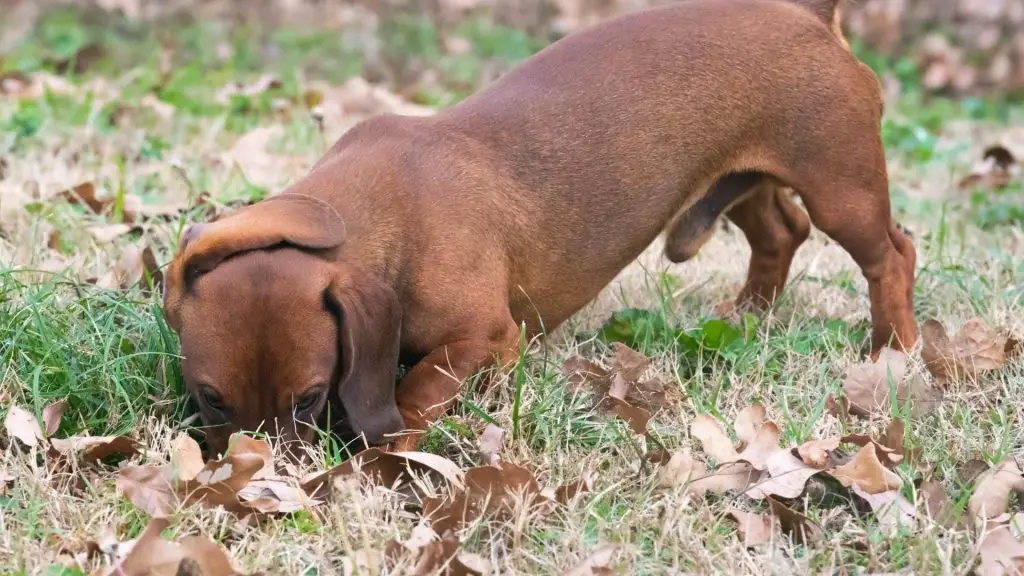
[[164, 194, 402, 454]]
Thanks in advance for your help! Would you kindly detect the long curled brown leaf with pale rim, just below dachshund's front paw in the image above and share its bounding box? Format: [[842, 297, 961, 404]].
[[300, 448, 465, 497]]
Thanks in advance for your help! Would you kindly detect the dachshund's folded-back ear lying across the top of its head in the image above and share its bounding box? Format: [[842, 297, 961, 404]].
[[164, 193, 345, 330]]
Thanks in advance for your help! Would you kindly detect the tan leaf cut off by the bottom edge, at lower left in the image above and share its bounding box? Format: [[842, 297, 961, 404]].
[[106, 518, 247, 576]]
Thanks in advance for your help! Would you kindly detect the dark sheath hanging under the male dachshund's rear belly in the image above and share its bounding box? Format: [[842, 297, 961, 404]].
[[665, 172, 765, 264]]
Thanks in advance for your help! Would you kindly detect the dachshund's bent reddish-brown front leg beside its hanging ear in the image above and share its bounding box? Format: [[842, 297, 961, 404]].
[[394, 322, 519, 451]]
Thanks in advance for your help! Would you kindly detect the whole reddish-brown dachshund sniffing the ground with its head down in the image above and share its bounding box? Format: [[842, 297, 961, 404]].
[[165, 0, 918, 451]]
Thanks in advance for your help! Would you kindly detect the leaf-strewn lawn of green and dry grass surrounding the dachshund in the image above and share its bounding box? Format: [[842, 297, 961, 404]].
[[0, 5, 1024, 575]]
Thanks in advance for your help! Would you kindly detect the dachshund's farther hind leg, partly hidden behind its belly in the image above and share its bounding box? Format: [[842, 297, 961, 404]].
[[726, 182, 811, 310]]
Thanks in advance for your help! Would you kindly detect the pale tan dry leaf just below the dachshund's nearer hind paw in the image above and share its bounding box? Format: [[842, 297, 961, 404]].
[[843, 347, 942, 417]]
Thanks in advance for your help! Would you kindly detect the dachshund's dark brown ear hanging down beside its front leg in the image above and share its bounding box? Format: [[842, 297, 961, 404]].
[[328, 274, 406, 445]]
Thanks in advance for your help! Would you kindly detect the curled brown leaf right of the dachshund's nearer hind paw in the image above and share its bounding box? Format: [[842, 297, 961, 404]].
[[921, 318, 1012, 386]]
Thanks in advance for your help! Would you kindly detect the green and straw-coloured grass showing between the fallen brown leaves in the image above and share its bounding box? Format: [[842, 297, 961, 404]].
[[0, 4, 1024, 574]]
